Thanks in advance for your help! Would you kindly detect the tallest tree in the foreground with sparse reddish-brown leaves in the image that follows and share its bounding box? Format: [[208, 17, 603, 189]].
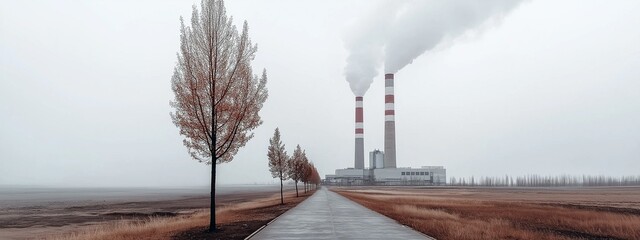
[[170, 0, 268, 232]]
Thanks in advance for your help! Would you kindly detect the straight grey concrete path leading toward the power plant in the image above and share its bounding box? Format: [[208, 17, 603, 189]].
[[251, 187, 429, 239]]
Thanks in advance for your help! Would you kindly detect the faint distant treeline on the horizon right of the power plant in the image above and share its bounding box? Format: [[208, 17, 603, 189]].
[[449, 174, 640, 187]]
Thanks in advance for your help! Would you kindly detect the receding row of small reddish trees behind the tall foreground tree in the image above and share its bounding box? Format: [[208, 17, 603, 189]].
[[267, 128, 321, 204]]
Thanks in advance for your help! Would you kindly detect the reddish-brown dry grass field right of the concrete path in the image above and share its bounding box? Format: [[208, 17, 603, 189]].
[[332, 187, 640, 239]]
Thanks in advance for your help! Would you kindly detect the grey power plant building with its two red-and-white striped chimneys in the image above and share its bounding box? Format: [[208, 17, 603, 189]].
[[325, 73, 446, 185]]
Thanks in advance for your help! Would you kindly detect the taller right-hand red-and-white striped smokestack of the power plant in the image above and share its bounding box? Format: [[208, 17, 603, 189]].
[[384, 73, 396, 168]]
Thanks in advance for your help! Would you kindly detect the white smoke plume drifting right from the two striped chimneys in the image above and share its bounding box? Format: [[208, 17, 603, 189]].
[[345, 0, 521, 96]]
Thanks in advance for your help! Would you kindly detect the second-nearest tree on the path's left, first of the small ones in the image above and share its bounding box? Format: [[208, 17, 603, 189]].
[[267, 128, 289, 204]]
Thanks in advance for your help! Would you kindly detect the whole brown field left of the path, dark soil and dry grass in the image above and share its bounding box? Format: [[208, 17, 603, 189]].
[[0, 186, 309, 240]]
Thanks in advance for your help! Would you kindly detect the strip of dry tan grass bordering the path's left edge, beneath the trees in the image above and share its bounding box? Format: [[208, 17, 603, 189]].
[[45, 191, 312, 240]]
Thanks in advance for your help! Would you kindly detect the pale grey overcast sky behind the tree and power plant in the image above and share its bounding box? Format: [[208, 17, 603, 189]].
[[0, 0, 640, 187]]
